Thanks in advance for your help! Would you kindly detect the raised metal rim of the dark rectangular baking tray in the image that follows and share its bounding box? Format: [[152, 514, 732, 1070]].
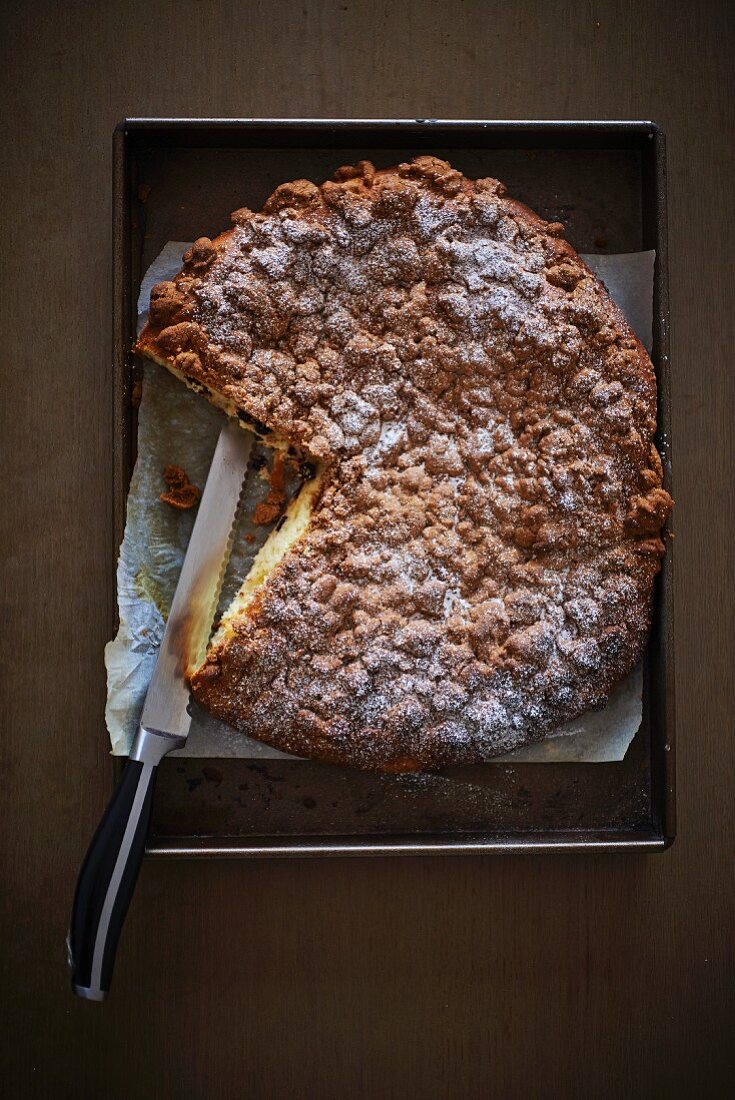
[[109, 118, 676, 858]]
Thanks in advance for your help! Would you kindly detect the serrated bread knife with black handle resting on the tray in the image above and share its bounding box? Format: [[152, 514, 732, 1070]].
[[67, 420, 253, 1001]]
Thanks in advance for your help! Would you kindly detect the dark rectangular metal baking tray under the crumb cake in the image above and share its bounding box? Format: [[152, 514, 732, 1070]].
[[109, 119, 674, 857]]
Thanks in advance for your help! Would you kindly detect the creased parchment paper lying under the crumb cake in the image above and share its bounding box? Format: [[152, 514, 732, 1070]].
[[105, 241, 655, 763]]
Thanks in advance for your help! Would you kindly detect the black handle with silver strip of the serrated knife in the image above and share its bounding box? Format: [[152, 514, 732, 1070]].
[[67, 730, 183, 1001]]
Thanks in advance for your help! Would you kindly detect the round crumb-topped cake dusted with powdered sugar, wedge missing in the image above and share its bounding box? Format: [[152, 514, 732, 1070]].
[[138, 156, 671, 771]]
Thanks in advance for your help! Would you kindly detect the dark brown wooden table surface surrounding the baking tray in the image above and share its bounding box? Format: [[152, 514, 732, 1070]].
[[0, 0, 735, 1100]]
